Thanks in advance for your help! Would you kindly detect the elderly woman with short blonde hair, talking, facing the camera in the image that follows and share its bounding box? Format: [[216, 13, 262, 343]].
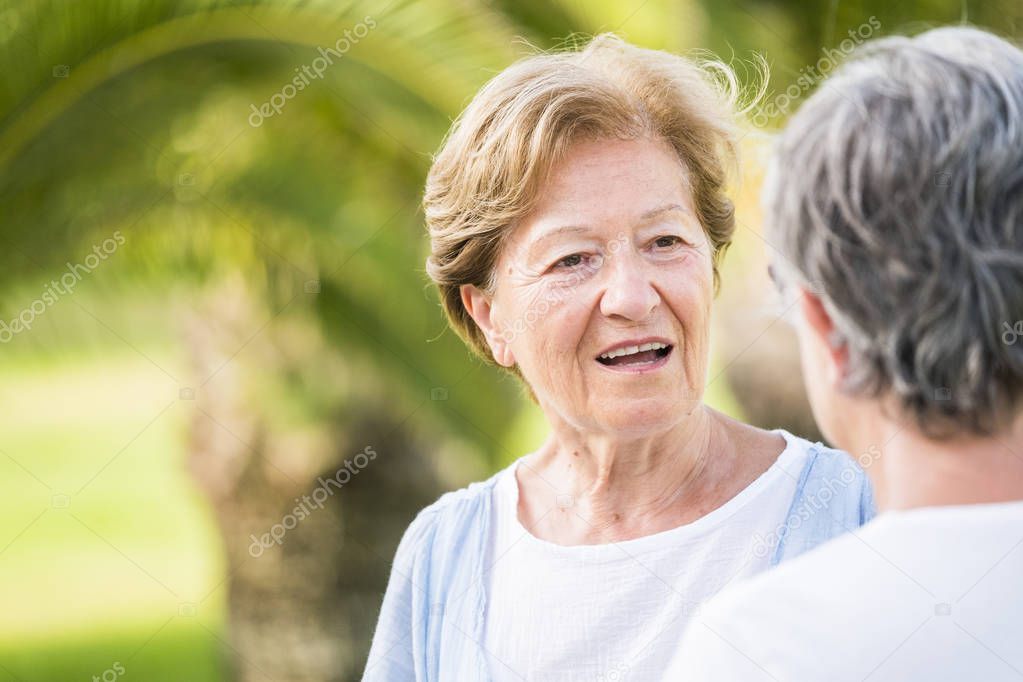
[[363, 36, 873, 682]]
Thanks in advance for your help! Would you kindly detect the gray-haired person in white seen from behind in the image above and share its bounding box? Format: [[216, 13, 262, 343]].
[[666, 27, 1023, 682]]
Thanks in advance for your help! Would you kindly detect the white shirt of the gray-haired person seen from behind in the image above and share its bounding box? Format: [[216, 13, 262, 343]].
[[665, 502, 1023, 682]]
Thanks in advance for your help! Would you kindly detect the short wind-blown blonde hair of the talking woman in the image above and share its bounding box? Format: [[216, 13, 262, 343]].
[[422, 34, 739, 384]]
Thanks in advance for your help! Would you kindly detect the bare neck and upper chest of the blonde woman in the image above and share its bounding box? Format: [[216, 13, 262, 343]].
[[518, 407, 784, 545]]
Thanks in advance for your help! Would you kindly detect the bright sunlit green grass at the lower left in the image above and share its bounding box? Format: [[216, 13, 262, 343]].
[[0, 347, 227, 682]]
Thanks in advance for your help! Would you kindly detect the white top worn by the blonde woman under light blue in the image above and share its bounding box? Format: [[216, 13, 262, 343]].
[[483, 429, 812, 682]]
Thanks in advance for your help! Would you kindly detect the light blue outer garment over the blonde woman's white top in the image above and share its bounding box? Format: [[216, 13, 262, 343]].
[[362, 435, 877, 682]]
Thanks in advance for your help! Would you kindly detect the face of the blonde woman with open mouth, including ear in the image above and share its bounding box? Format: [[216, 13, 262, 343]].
[[462, 139, 713, 436]]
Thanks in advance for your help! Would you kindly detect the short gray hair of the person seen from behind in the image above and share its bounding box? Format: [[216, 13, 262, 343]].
[[763, 27, 1023, 435]]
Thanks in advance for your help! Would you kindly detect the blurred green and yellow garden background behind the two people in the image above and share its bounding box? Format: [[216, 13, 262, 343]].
[[0, 0, 1023, 682]]
